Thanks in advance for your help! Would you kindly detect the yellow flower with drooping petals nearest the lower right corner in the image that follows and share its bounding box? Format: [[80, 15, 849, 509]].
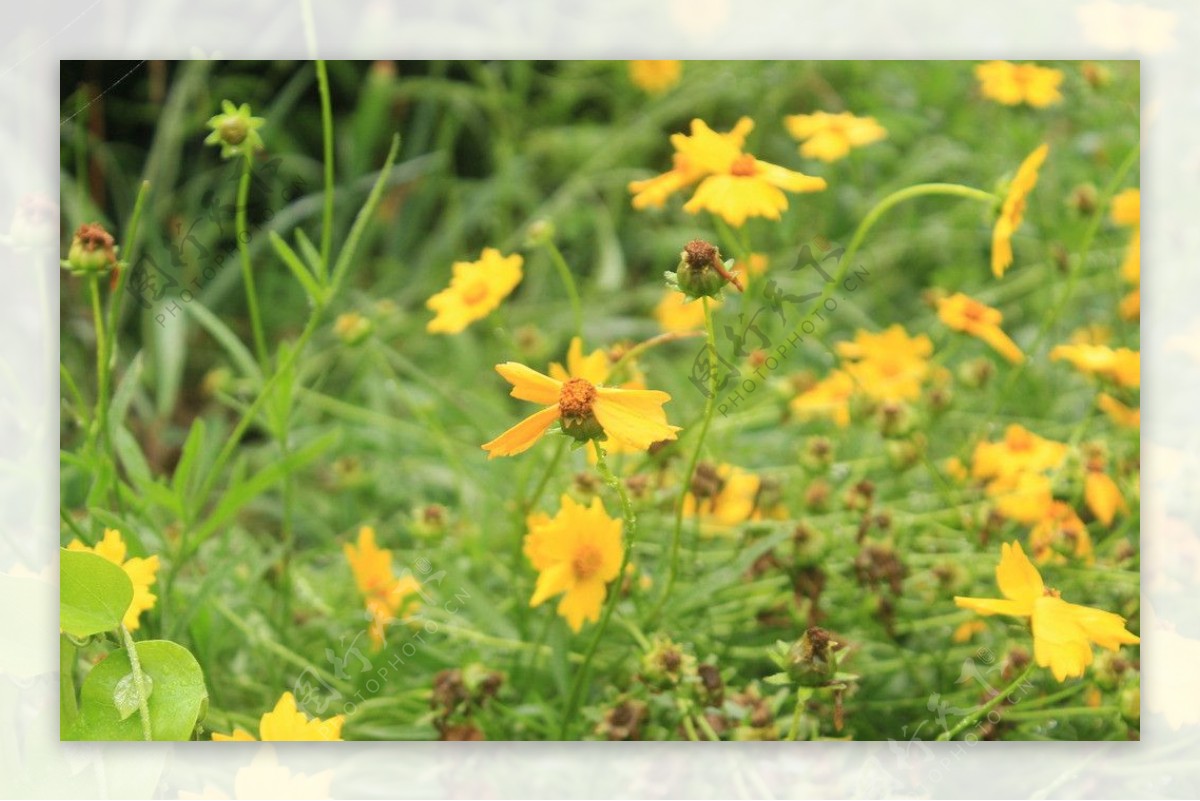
[[954, 542, 1141, 681]]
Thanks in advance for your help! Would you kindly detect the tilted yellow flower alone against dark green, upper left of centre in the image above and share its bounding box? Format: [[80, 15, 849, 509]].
[[425, 247, 524, 333]]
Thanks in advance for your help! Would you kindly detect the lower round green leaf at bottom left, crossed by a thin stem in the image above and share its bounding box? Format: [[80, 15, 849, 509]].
[[64, 640, 209, 740]]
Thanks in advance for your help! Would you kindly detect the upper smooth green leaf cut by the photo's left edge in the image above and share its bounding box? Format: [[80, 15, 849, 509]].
[[59, 548, 133, 638]]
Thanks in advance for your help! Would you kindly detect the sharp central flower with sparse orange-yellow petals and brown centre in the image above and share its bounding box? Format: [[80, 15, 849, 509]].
[[482, 362, 679, 459]]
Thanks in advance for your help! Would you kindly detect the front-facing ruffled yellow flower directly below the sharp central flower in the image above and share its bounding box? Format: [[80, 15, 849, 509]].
[[524, 495, 622, 632]]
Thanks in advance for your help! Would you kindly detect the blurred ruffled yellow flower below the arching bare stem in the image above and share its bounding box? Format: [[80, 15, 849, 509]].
[[835, 324, 934, 401]]
